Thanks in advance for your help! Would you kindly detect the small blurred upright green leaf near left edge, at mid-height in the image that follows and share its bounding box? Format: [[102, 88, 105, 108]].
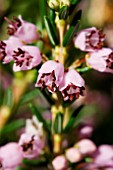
[[3, 87, 13, 107]]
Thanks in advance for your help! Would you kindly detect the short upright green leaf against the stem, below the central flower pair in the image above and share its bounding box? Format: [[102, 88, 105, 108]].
[[53, 112, 63, 134]]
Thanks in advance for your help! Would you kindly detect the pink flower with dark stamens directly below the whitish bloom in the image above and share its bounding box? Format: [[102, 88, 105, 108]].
[[19, 133, 44, 159]]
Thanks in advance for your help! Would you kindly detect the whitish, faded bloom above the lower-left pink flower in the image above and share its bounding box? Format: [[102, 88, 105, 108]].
[[25, 116, 43, 136]]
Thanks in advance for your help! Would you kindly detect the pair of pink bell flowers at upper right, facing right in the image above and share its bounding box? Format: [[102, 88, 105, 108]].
[[74, 27, 113, 73]]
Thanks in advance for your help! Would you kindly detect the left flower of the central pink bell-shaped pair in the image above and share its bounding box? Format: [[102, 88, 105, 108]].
[[36, 60, 64, 92]]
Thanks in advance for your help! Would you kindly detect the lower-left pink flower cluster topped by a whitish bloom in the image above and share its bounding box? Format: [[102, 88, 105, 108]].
[[0, 116, 44, 170]]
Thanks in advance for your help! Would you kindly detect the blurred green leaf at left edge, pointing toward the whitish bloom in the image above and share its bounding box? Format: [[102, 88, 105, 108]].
[[0, 119, 25, 135]]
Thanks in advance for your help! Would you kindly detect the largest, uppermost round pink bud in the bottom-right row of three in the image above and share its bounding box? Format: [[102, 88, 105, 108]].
[[75, 139, 96, 155]]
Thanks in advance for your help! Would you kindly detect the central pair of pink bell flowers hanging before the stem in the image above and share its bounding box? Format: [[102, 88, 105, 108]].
[[36, 61, 85, 101]]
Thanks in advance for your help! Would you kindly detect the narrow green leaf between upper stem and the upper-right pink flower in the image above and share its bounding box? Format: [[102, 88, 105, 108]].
[[63, 22, 80, 46]]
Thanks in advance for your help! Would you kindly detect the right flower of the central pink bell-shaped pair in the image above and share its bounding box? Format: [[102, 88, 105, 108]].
[[59, 70, 85, 101]]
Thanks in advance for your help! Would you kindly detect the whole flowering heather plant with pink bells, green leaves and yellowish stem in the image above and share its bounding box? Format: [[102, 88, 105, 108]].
[[0, 0, 113, 170]]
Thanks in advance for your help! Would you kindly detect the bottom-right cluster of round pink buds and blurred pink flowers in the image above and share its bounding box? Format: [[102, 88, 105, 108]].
[[52, 138, 113, 170]]
